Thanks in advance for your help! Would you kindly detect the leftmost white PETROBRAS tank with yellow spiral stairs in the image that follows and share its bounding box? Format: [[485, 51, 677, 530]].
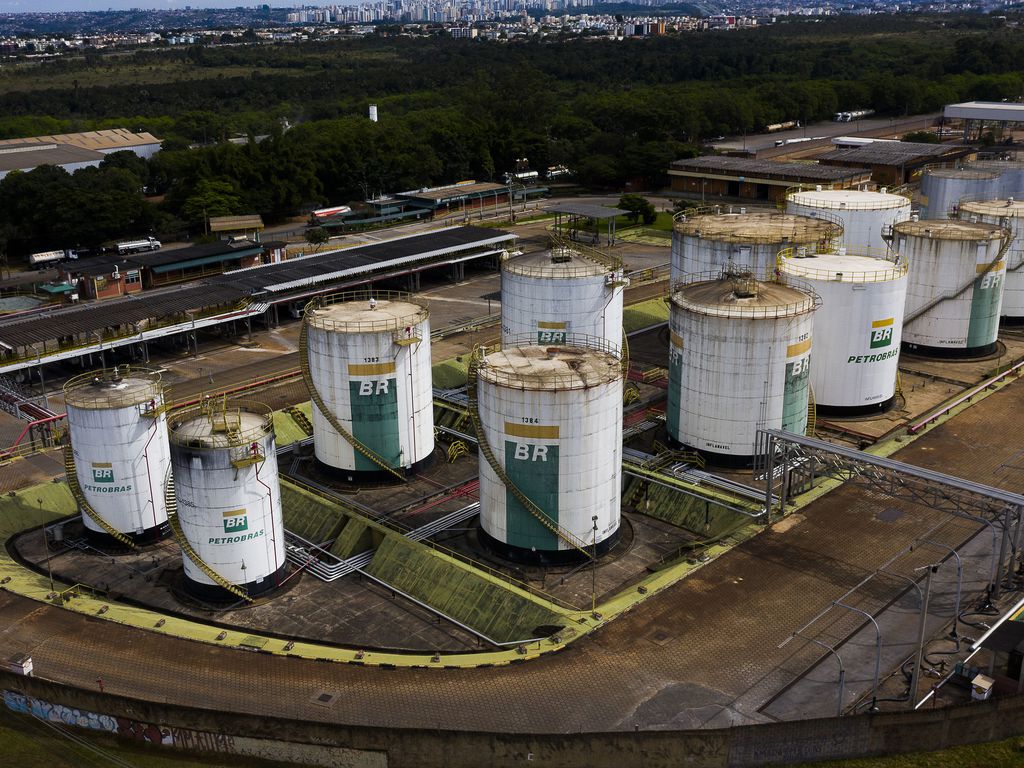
[[65, 366, 171, 544]]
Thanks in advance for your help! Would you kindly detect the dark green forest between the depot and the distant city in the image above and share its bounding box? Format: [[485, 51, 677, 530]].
[[0, 15, 1024, 260]]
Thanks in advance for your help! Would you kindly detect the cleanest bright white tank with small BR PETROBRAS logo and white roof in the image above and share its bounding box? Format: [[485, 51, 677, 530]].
[[779, 249, 907, 415]]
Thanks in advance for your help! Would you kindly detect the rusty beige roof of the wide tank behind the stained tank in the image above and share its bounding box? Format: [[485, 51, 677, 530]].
[[673, 211, 843, 244]]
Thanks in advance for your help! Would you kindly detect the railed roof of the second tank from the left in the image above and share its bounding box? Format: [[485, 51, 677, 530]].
[[168, 402, 273, 449]]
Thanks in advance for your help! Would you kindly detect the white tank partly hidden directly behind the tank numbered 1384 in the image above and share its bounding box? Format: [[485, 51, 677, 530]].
[[502, 246, 626, 345]]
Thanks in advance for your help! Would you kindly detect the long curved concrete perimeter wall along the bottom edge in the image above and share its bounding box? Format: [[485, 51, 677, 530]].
[[6, 671, 1024, 768]]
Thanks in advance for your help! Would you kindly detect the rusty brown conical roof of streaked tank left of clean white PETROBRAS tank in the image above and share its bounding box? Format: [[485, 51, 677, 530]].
[[671, 276, 819, 318]]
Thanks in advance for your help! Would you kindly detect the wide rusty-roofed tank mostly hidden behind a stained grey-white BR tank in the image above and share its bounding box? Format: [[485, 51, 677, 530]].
[[671, 208, 843, 283]]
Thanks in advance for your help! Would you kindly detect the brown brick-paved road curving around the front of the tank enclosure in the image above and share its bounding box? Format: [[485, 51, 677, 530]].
[[0, 376, 1024, 732]]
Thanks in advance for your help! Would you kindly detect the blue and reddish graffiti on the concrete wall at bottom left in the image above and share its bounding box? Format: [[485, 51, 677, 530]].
[[3, 690, 234, 753]]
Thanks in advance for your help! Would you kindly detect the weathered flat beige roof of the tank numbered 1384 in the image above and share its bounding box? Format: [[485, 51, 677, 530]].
[[479, 345, 623, 391]]
